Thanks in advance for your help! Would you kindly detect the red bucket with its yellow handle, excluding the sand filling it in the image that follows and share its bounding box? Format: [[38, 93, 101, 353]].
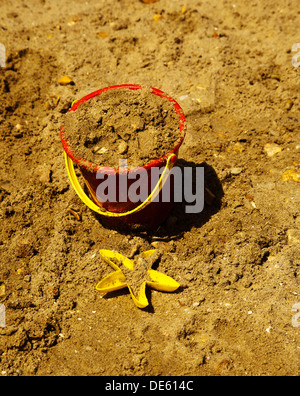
[[60, 84, 186, 230]]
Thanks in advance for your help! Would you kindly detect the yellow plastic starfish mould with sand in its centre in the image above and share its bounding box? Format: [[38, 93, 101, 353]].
[[96, 249, 180, 308]]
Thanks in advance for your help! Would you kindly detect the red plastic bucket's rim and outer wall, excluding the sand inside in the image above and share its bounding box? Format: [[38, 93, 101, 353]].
[[60, 84, 186, 229]]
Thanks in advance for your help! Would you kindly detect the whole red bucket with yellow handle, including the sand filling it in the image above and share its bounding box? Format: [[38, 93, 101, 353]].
[[60, 85, 186, 229]]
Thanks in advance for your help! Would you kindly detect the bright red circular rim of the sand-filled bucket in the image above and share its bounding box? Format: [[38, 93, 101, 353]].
[[60, 84, 186, 174]]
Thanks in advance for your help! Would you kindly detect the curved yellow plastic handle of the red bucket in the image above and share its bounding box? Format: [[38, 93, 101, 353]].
[[64, 153, 176, 217]]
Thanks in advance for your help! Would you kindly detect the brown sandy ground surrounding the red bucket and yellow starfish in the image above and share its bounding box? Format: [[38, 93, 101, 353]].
[[0, 0, 300, 376]]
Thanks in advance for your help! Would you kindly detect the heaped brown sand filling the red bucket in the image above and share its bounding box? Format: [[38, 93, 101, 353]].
[[64, 89, 180, 168]]
